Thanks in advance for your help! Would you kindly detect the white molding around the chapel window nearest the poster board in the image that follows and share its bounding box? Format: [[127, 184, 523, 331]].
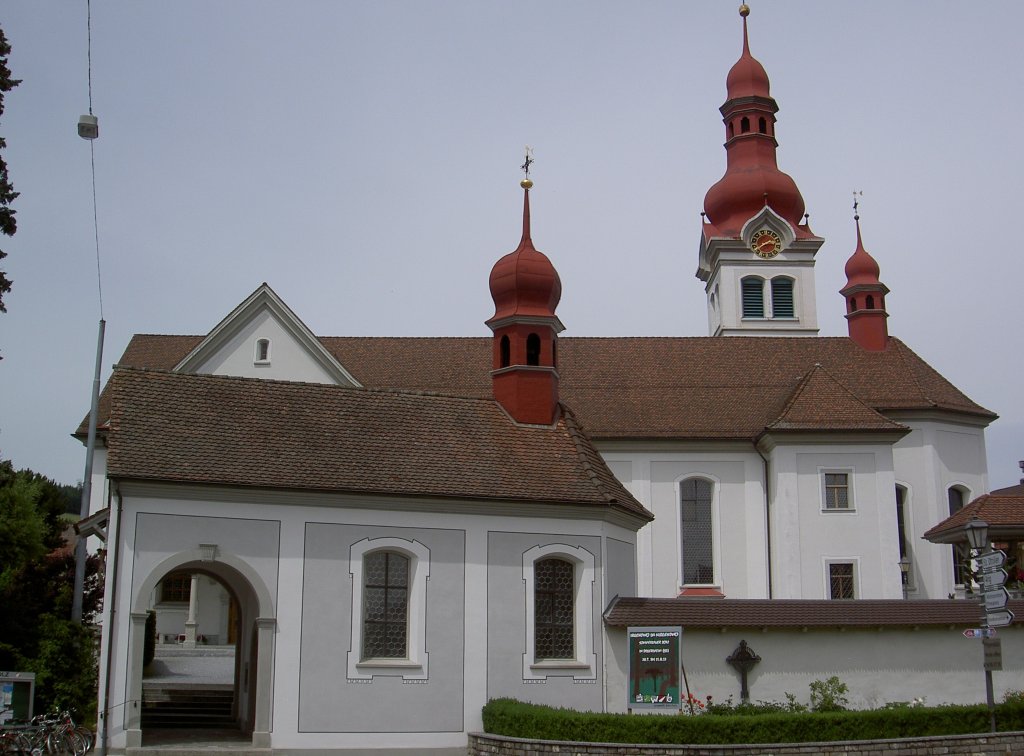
[[522, 543, 597, 681]]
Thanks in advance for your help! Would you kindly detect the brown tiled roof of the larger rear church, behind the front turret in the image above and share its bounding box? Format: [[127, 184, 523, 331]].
[[94, 336, 995, 439]]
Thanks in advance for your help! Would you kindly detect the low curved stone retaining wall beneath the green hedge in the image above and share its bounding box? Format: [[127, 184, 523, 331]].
[[466, 731, 1024, 756]]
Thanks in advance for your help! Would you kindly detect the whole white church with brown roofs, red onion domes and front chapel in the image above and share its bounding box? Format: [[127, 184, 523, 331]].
[[79, 6, 996, 754]]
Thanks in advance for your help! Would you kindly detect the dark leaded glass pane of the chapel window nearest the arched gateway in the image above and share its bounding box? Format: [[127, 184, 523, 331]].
[[362, 551, 409, 659]]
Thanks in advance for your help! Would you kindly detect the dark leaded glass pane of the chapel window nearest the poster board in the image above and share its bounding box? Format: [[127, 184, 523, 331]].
[[534, 557, 575, 661]]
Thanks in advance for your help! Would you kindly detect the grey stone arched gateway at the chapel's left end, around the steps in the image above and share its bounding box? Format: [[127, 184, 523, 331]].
[[125, 544, 276, 747]]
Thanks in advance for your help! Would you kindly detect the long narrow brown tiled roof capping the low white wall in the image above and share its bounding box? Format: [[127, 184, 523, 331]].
[[604, 597, 1024, 628]]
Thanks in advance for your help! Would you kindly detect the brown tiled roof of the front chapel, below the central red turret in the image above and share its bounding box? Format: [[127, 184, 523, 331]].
[[108, 369, 652, 518]]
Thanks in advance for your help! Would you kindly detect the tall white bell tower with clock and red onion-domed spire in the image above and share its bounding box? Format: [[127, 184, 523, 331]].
[[696, 3, 824, 336]]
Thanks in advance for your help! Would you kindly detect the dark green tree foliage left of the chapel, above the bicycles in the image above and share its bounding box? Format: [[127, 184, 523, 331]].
[[0, 461, 102, 721]]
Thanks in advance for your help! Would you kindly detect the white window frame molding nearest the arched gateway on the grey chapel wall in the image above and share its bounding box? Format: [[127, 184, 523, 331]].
[[346, 537, 430, 680]]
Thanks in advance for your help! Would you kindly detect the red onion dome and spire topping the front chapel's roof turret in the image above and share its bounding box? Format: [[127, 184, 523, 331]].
[[487, 178, 562, 323]]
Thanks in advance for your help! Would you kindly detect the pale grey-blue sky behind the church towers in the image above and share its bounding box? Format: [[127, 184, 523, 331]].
[[0, 0, 1024, 488]]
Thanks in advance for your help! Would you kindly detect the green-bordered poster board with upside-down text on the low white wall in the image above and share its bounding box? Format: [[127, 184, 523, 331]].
[[626, 627, 683, 709]]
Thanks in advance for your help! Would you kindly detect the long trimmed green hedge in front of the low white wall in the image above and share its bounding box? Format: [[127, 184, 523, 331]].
[[483, 699, 1024, 745]]
